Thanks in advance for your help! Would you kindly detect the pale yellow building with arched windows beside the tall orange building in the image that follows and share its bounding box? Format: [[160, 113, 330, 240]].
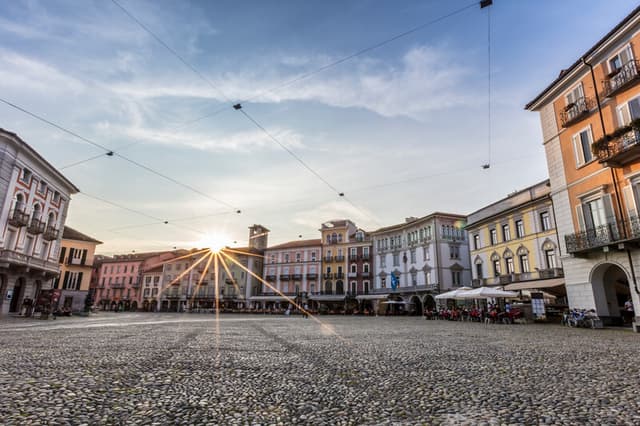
[[466, 180, 566, 297]]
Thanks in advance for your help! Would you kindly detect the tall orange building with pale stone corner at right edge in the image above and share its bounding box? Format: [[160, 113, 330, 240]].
[[526, 7, 640, 324]]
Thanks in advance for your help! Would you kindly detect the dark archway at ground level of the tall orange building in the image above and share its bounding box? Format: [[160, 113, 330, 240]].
[[590, 263, 631, 325]]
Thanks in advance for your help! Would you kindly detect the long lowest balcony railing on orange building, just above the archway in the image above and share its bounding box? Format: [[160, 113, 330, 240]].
[[564, 217, 628, 254]]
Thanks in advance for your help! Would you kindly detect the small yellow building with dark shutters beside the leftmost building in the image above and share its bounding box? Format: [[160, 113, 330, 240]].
[[53, 226, 102, 312]]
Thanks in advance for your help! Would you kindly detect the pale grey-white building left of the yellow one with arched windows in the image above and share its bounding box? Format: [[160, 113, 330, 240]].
[[370, 213, 471, 315]]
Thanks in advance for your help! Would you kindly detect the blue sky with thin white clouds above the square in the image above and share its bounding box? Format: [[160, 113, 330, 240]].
[[0, 0, 636, 253]]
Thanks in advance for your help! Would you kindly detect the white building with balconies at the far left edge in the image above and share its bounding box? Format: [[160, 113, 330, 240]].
[[0, 129, 79, 314]]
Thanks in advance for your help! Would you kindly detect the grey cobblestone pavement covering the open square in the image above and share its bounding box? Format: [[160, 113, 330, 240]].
[[0, 313, 640, 425]]
